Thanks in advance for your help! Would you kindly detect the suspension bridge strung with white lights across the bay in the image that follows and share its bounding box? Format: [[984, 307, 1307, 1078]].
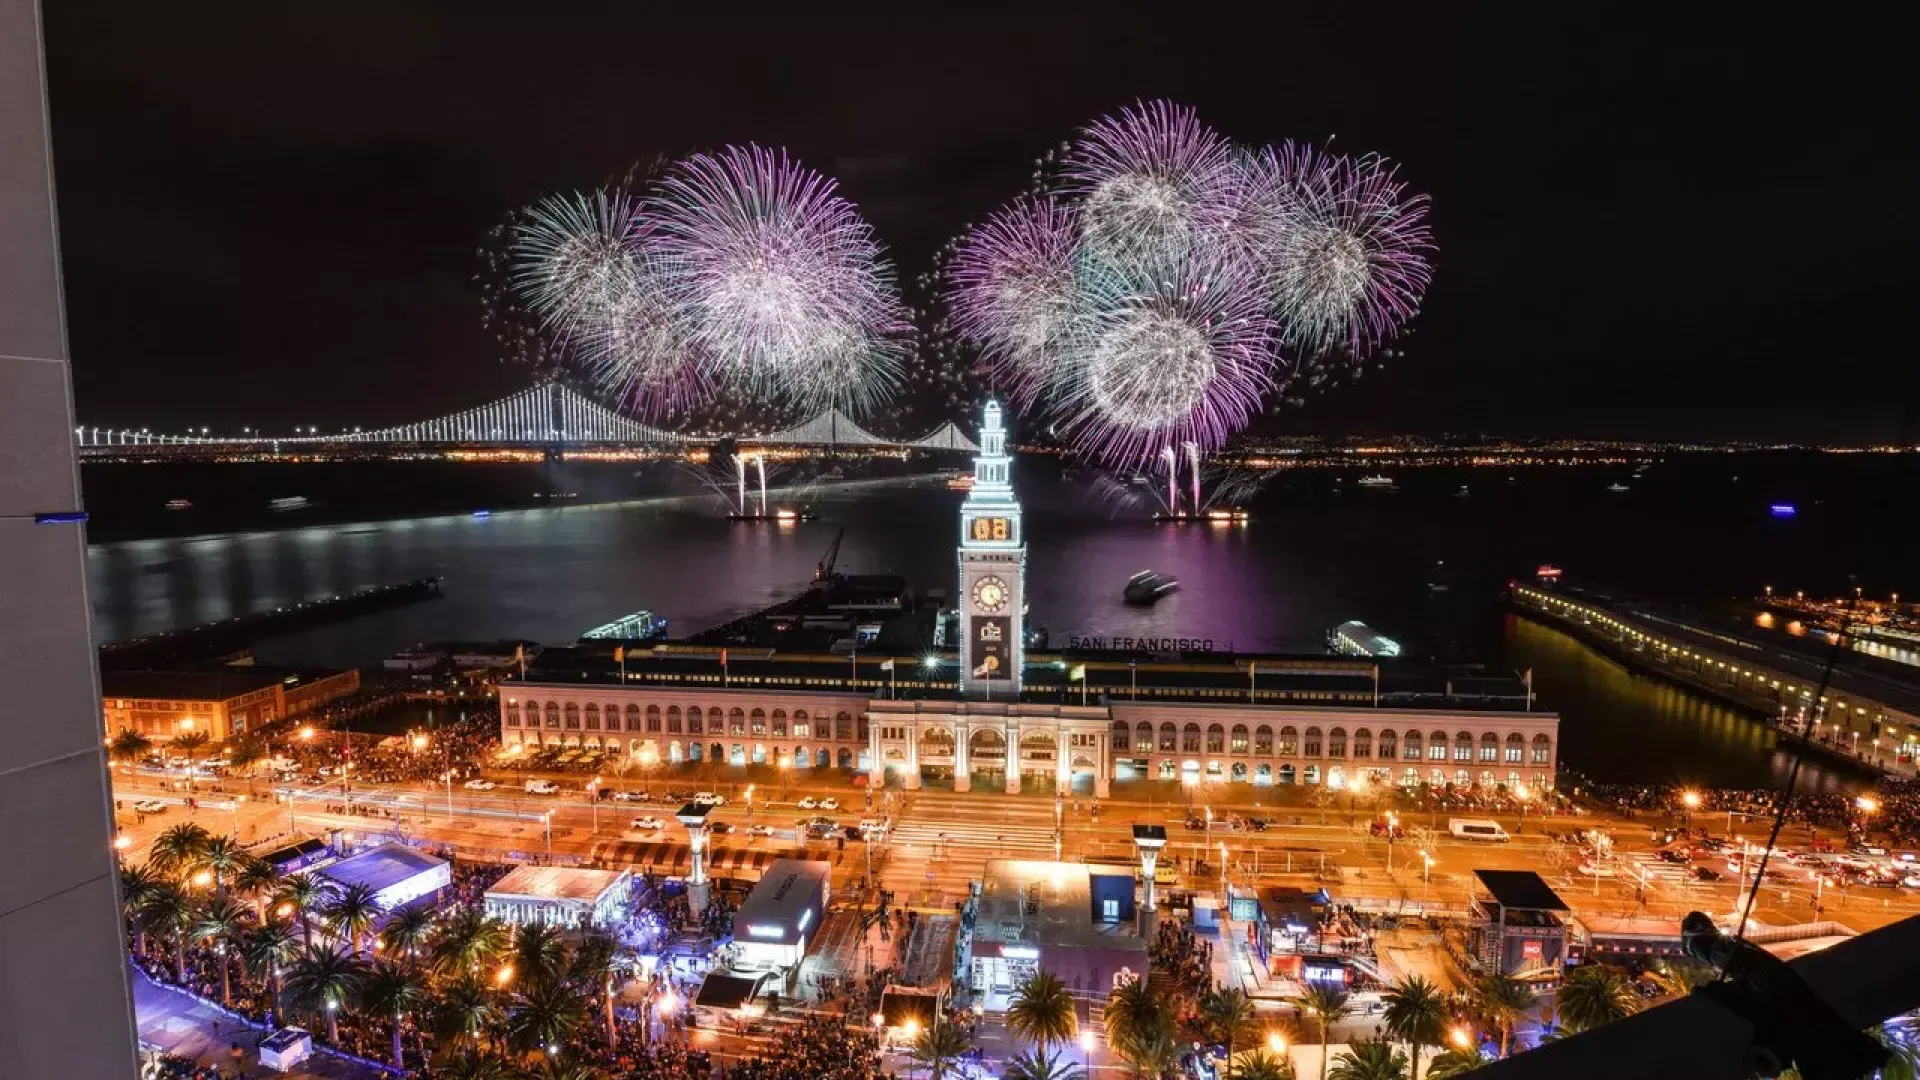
[[73, 382, 979, 455]]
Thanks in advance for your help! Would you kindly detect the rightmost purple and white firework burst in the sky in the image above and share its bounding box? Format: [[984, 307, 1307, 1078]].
[[1261, 144, 1434, 357]]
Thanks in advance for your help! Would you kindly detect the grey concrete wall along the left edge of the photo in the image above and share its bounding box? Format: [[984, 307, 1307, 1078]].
[[0, 0, 134, 1080]]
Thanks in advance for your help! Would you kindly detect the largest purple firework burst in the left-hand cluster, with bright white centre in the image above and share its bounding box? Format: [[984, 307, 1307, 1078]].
[[653, 146, 908, 413]]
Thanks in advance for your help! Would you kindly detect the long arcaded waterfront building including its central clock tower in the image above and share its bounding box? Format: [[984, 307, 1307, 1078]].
[[499, 402, 1559, 798]]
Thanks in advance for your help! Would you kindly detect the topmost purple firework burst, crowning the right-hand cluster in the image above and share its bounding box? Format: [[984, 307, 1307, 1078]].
[[1064, 102, 1235, 267]]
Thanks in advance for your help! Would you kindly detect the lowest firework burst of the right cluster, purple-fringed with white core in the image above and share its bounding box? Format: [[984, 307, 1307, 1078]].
[[1056, 259, 1275, 465]]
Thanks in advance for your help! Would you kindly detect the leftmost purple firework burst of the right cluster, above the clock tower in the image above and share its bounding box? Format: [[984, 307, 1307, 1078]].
[[947, 198, 1079, 405]]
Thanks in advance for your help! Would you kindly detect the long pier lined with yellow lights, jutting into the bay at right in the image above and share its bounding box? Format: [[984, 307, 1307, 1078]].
[[1509, 584, 1920, 776]]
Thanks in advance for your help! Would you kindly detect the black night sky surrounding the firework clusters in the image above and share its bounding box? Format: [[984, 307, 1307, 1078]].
[[46, 0, 1920, 440]]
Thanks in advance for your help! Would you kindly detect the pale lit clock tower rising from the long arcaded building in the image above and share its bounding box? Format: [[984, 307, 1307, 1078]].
[[956, 400, 1027, 700]]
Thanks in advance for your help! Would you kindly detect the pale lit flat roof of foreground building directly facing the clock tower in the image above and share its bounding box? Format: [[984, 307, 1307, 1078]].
[[973, 859, 1146, 947]]
